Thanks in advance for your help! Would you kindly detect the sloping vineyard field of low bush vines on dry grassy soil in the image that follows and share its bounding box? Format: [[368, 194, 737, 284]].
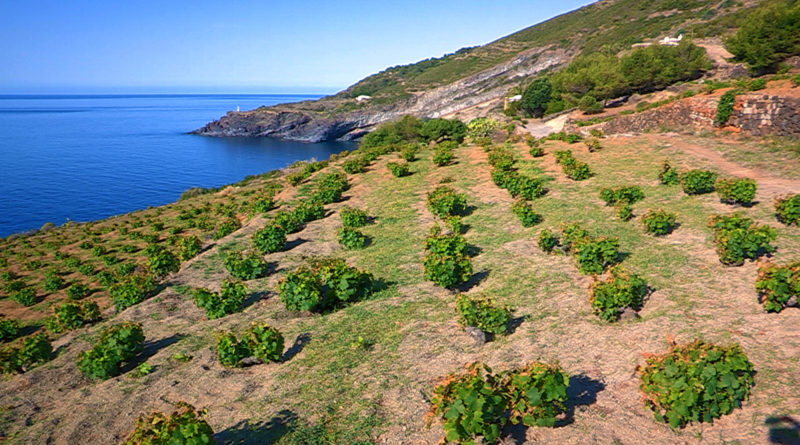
[[0, 127, 800, 444]]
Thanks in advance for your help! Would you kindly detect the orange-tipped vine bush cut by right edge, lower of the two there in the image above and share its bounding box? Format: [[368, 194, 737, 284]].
[[756, 261, 800, 312]]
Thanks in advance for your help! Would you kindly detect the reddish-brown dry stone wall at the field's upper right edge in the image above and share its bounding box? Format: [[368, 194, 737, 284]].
[[567, 93, 800, 136]]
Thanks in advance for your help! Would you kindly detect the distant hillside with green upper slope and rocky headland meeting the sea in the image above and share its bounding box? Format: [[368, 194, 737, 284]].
[[196, 0, 769, 142]]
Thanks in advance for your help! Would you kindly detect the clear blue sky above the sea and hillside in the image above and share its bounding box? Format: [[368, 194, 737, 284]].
[[0, 0, 591, 93]]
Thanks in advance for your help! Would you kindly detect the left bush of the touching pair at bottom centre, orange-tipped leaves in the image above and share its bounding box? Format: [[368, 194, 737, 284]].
[[427, 363, 508, 443]]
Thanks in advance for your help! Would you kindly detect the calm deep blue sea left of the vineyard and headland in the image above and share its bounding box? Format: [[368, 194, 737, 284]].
[[0, 95, 353, 237]]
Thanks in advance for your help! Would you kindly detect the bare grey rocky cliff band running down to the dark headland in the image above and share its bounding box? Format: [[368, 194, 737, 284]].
[[193, 48, 574, 142]]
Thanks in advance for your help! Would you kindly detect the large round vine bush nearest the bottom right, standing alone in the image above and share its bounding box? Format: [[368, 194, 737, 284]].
[[639, 340, 755, 428]]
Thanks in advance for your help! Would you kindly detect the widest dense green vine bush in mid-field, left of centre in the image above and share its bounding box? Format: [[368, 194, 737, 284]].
[[278, 259, 373, 312]]
